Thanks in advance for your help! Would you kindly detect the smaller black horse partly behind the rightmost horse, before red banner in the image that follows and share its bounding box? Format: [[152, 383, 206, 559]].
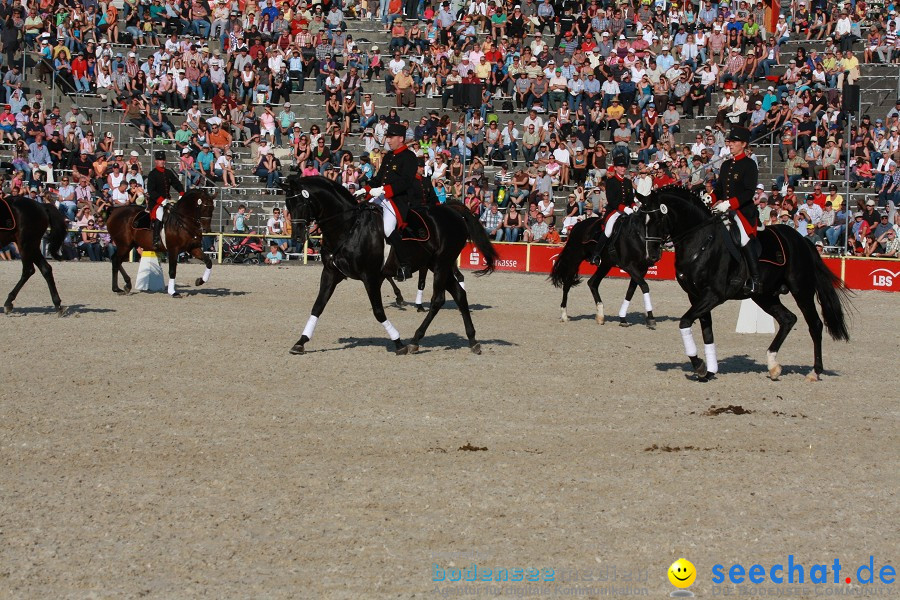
[[550, 209, 663, 329]]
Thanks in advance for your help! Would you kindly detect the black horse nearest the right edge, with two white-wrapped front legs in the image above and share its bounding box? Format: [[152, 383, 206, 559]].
[[642, 186, 849, 381]]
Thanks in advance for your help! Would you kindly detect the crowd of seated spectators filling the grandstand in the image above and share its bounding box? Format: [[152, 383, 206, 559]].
[[0, 0, 900, 260]]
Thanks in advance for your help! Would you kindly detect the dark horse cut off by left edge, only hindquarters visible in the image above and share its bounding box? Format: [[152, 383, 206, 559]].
[[0, 196, 66, 316]]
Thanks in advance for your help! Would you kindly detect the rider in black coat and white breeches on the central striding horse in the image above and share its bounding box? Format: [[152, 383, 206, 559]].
[[356, 123, 422, 281]]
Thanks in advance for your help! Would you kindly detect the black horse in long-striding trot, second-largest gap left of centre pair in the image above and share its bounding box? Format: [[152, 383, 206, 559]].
[[281, 175, 497, 354]]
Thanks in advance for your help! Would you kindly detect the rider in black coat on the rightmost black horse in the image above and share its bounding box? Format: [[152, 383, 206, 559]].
[[713, 127, 760, 294]]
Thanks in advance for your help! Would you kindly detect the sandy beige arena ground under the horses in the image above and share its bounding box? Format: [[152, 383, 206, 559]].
[[0, 263, 900, 599]]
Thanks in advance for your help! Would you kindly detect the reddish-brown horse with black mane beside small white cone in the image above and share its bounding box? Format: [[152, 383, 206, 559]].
[[106, 188, 213, 298]]
